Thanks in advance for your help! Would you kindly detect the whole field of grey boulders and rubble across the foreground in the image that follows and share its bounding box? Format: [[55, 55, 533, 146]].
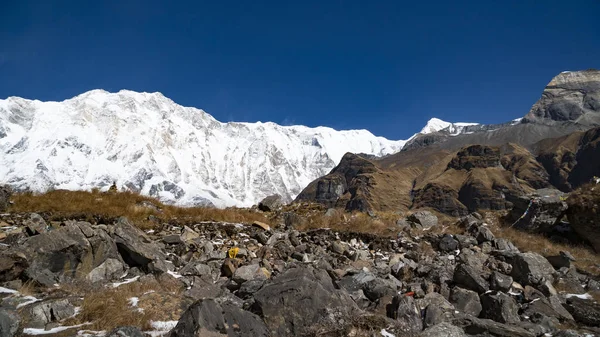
[[0, 203, 600, 337]]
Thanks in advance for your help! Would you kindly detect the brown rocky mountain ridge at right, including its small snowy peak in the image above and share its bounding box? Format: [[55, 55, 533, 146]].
[[296, 70, 600, 216]]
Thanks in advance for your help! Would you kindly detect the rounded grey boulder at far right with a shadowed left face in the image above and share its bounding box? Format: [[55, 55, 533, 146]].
[[510, 252, 555, 286]]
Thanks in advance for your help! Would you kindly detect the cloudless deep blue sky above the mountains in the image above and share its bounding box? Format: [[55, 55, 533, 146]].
[[0, 0, 600, 139]]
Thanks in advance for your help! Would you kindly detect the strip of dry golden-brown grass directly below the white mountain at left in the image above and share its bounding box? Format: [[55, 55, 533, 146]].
[[10, 190, 269, 228]]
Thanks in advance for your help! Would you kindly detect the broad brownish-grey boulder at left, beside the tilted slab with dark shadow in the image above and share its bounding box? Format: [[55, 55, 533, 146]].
[[15, 222, 121, 286]]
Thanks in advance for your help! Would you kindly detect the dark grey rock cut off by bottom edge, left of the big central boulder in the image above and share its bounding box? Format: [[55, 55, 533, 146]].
[[170, 299, 269, 337]]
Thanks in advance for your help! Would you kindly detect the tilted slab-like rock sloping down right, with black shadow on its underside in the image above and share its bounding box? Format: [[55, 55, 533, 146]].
[[112, 217, 168, 273]]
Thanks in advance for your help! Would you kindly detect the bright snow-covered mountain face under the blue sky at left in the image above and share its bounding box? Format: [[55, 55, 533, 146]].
[[0, 90, 404, 206]]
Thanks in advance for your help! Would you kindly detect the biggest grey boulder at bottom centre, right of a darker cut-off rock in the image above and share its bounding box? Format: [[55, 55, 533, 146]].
[[254, 267, 358, 336]]
